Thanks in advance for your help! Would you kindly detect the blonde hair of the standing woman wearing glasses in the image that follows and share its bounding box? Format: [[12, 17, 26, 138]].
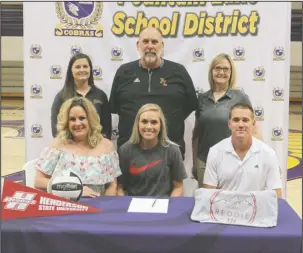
[[208, 53, 237, 90]]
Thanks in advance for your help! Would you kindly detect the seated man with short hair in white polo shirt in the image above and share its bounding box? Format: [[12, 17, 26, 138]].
[[203, 104, 282, 198]]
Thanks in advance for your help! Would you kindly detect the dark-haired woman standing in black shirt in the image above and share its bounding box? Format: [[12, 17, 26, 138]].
[[51, 53, 112, 140]]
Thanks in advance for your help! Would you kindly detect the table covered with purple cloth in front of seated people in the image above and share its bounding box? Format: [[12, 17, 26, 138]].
[[2, 197, 302, 253]]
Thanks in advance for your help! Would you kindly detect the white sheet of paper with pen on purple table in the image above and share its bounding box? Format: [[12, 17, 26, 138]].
[[128, 198, 169, 213]]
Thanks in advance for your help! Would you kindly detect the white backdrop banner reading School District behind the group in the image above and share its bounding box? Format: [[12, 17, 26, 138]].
[[24, 1, 291, 196]]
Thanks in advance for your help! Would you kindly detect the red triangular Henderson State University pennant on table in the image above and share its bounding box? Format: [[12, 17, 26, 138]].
[[2, 180, 102, 220]]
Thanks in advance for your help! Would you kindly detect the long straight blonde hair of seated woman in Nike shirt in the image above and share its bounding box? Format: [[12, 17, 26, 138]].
[[129, 104, 177, 147]]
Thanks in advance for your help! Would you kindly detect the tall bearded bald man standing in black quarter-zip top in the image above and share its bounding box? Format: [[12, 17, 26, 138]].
[[109, 28, 197, 158]]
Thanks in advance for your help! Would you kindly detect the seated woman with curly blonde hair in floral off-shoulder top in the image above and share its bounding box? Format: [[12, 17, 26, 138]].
[[35, 97, 121, 197]]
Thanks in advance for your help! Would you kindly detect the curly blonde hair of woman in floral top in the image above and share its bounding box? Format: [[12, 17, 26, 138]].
[[57, 97, 102, 148]]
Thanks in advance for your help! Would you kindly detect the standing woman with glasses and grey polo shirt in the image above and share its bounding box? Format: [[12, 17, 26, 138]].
[[193, 54, 261, 187]]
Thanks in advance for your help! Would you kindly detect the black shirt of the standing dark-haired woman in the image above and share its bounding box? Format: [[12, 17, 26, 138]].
[[51, 85, 112, 140]]
